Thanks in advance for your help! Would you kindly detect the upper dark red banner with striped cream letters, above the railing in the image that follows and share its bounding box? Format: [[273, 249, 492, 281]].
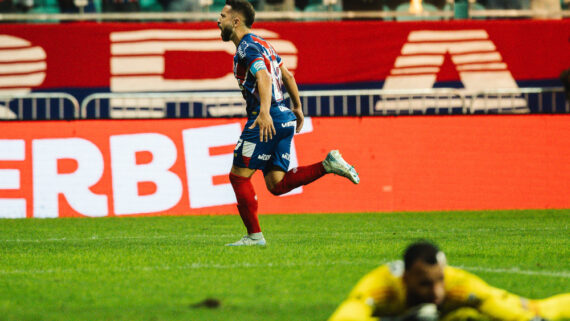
[[0, 19, 570, 93]]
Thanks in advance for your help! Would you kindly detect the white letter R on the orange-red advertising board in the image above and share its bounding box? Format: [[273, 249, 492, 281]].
[[32, 138, 108, 218]]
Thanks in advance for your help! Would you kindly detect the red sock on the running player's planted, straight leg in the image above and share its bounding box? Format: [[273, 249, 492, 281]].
[[230, 173, 261, 234]]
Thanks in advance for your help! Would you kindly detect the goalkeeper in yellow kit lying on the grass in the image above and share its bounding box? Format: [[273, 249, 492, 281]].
[[329, 242, 570, 321]]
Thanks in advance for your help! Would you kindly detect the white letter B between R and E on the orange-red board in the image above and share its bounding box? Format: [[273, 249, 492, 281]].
[[111, 133, 182, 215]]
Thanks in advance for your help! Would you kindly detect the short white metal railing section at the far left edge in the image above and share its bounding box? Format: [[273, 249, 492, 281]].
[[0, 93, 80, 120]]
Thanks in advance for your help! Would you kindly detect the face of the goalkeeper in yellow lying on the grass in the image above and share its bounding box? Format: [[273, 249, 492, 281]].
[[404, 260, 445, 306]]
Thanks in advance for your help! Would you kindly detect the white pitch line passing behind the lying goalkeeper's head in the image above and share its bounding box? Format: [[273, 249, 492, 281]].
[[0, 259, 570, 279]]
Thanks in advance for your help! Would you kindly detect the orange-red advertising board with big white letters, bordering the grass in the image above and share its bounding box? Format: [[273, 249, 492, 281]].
[[0, 115, 570, 218]]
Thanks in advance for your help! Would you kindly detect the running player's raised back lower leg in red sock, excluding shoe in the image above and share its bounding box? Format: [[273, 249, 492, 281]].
[[265, 162, 326, 195]]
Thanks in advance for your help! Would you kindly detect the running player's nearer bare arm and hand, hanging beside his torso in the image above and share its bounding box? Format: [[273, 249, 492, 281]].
[[250, 69, 276, 142]]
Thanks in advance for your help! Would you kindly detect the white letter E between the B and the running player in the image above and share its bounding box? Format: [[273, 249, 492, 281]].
[[182, 123, 241, 208]]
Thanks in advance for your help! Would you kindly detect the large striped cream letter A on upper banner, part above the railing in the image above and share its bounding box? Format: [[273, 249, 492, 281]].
[[383, 29, 518, 90]]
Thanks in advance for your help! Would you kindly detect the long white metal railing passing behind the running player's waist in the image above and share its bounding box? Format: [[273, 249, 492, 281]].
[[81, 87, 570, 118]]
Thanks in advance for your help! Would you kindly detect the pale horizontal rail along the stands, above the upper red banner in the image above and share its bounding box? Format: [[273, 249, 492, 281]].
[[0, 9, 570, 22]]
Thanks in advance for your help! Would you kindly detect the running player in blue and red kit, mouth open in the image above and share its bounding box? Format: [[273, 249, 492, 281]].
[[218, 0, 360, 246]]
